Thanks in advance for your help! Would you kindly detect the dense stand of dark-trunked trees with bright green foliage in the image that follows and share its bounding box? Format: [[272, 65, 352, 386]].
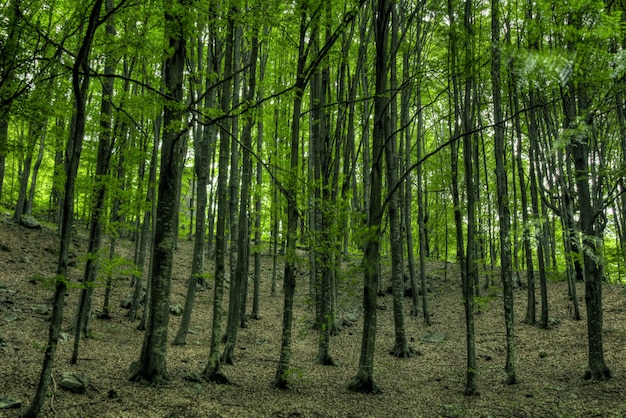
[[0, 0, 626, 416]]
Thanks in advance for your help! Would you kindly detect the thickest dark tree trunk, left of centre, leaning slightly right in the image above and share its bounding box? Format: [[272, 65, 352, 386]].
[[130, 0, 189, 384]]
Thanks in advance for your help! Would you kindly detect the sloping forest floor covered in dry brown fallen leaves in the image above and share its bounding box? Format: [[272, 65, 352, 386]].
[[0, 216, 626, 417]]
